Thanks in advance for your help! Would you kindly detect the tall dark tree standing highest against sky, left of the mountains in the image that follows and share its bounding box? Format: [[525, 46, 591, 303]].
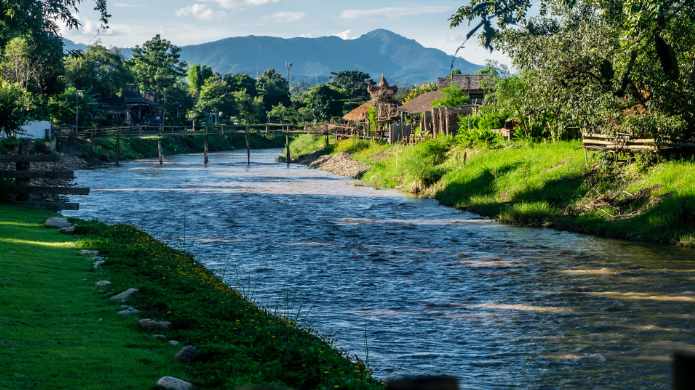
[[130, 34, 186, 102]]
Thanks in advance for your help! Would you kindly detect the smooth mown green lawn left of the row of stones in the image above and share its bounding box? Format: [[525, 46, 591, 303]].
[[0, 205, 183, 389]]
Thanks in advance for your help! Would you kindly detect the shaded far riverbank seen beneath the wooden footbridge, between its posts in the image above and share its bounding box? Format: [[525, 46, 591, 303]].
[[65, 134, 285, 164]]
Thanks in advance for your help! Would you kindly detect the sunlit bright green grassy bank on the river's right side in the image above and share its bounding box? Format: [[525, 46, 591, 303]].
[[293, 136, 695, 246]]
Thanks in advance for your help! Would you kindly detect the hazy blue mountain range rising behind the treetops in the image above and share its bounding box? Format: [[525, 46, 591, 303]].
[[65, 29, 481, 86]]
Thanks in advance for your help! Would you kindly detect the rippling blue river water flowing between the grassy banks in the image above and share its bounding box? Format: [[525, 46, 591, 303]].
[[66, 150, 695, 389]]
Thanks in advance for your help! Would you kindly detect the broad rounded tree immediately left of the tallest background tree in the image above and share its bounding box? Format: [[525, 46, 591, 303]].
[[65, 44, 134, 99]]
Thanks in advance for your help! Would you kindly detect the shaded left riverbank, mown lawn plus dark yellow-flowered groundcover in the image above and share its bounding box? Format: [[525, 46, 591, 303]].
[[0, 205, 380, 389]]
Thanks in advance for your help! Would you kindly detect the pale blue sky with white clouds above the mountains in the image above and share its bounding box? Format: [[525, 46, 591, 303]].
[[64, 0, 508, 63]]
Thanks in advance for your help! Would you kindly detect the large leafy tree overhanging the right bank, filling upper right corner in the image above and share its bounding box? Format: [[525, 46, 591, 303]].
[[450, 0, 695, 138]]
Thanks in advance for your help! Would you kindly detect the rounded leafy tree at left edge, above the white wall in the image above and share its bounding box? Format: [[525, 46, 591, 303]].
[[0, 78, 33, 137]]
